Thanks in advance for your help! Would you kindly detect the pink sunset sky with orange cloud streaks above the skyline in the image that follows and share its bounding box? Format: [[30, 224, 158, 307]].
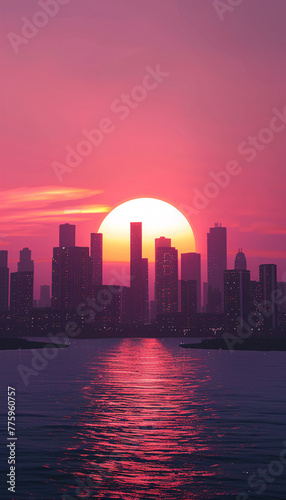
[[0, 0, 286, 295]]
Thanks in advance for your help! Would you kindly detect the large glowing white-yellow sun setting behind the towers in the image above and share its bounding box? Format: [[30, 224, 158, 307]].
[[98, 198, 196, 262]]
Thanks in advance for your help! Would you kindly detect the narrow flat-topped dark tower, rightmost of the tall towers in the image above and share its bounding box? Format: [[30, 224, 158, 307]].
[[259, 264, 278, 334]]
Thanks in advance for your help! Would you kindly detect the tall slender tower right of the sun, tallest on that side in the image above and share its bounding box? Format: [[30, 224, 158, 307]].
[[207, 223, 227, 313]]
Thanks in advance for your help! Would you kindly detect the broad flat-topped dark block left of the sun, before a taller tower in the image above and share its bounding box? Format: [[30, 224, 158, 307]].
[[52, 247, 90, 310]]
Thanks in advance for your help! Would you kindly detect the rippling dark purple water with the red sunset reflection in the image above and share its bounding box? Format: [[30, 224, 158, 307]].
[[0, 339, 286, 500]]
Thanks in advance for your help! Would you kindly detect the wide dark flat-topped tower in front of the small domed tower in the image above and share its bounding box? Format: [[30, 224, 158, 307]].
[[224, 270, 250, 332]]
